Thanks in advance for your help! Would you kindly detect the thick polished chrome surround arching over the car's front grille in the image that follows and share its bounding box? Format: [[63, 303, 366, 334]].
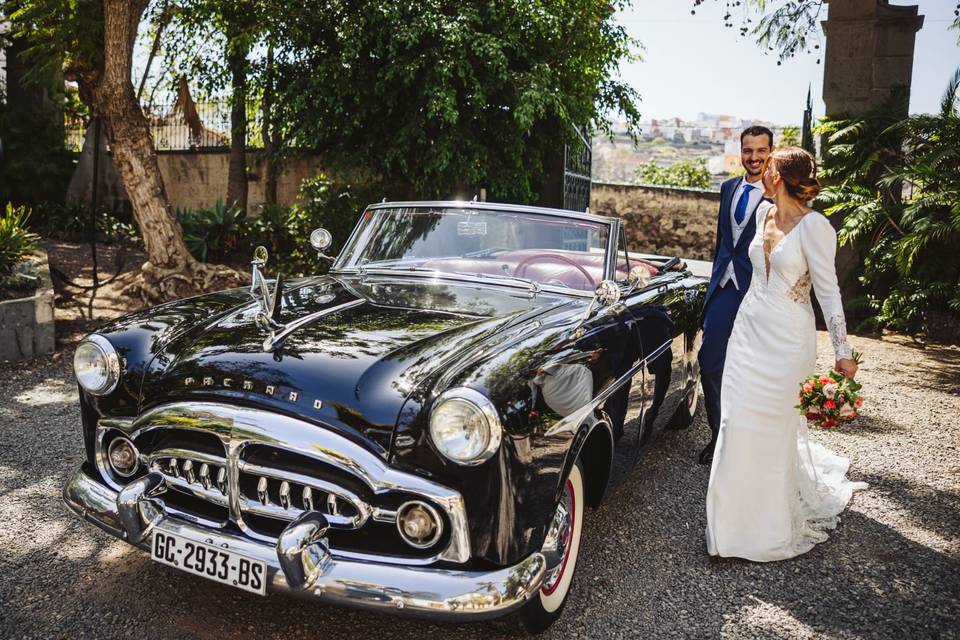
[[96, 402, 470, 564]]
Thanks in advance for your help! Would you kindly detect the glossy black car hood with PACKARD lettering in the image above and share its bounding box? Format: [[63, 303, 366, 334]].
[[140, 276, 582, 455]]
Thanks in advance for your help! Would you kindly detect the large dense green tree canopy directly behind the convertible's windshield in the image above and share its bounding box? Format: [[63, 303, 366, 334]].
[[271, 0, 639, 200]]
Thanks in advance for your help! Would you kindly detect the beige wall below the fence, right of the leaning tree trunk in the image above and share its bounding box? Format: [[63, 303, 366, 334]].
[[157, 151, 321, 213]]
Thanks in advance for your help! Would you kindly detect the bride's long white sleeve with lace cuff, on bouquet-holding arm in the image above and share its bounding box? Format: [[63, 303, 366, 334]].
[[802, 212, 853, 360]]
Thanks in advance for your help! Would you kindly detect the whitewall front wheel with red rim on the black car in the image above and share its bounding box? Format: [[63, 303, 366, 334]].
[[519, 460, 586, 635]]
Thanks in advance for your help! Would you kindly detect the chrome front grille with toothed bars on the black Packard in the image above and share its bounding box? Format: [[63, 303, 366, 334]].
[[95, 402, 470, 564]]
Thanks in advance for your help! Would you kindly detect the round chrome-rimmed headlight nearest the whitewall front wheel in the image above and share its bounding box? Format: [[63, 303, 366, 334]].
[[430, 387, 502, 465]]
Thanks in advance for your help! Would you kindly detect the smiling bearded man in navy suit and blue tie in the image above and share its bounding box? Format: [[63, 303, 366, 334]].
[[698, 126, 773, 464]]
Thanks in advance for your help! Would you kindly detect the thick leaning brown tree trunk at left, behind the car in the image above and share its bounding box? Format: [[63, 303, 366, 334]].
[[72, 0, 242, 302]]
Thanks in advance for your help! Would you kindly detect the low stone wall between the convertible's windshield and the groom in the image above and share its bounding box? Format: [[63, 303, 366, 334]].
[[590, 182, 720, 260]]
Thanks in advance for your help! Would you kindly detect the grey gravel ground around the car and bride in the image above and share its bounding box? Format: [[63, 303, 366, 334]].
[[0, 334, 960, 640]]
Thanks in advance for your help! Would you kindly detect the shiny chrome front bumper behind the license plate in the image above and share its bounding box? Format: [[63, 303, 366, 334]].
[[63, 468, 546, 621]]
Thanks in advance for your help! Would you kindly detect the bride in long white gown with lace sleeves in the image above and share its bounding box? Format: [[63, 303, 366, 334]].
[[706, 147, 866, 562]]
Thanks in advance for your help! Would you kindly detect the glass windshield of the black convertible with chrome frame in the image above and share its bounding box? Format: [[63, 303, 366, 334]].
[[334, 207, 609, 292]]
